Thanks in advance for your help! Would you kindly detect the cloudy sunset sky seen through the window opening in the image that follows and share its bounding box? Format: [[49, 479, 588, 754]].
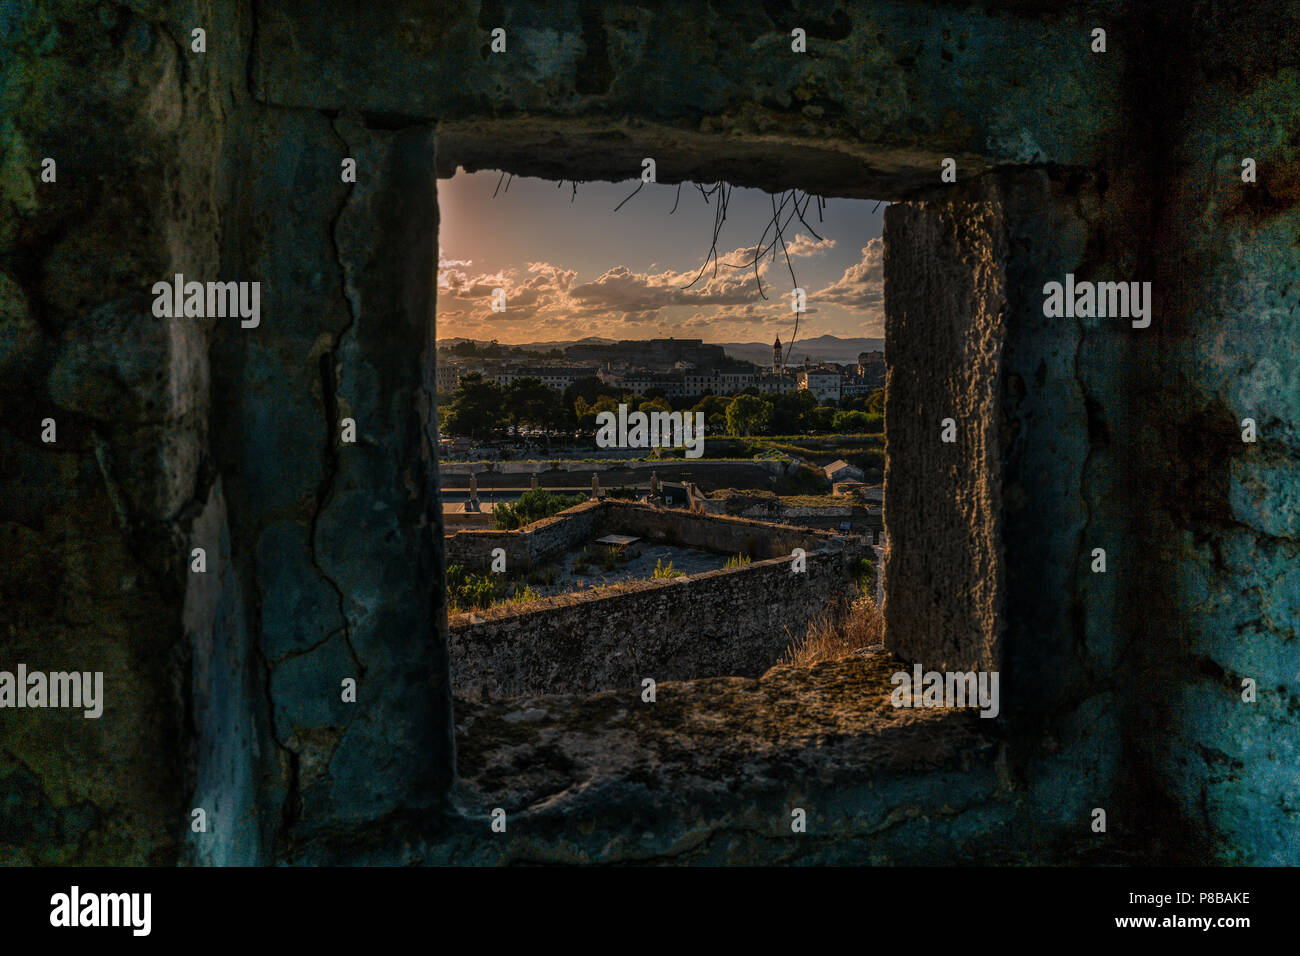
[[438, 172, 885, 343]]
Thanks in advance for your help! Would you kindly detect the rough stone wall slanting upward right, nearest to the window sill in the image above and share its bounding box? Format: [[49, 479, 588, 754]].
[[447, 546, 858, 697]]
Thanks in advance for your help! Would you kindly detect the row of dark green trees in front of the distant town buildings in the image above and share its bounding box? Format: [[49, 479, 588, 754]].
[[438, 373, 884, 438]]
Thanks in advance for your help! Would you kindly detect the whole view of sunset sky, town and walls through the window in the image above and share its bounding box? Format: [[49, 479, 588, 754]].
[[437, 172, 885, 696]]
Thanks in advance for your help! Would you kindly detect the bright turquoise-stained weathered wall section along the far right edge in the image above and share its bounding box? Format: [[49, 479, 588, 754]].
[[1128, 3, 1300, 866]]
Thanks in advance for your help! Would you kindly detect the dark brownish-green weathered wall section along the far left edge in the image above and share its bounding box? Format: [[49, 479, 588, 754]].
[[0, 3, 244, 865]]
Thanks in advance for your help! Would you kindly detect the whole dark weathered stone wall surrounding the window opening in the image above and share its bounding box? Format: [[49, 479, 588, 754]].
[[0, 0, 1300, 862]]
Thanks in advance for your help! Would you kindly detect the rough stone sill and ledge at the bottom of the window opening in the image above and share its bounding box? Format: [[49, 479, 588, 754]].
[[289, 654, 1032, 865]]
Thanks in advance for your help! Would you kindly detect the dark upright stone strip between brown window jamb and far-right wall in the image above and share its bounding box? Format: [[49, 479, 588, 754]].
[[977, 170, 1128, 842]]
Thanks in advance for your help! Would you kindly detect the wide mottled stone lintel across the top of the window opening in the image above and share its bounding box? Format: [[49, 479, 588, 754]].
[[254, 0, 1123, 198]]
